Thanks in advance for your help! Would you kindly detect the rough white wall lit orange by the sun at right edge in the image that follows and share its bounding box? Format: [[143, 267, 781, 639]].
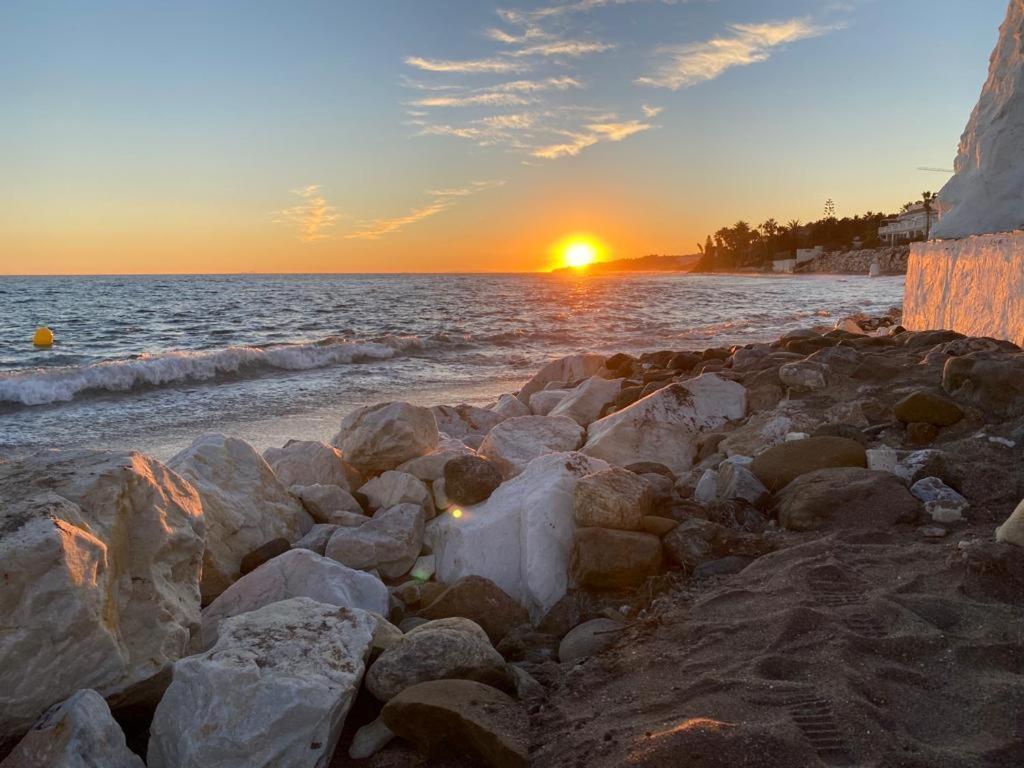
[[903, 232, 1024, 345]]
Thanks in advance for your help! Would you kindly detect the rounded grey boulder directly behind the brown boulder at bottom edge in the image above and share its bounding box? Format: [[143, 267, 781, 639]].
[[366, 617, 506, 700]]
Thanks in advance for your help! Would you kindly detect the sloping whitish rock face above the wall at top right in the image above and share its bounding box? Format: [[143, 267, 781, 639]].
[[932, 0, 1024, 238]]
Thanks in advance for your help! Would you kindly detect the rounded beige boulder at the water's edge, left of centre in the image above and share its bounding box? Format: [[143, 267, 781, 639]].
[[333, 402, 439, 473]]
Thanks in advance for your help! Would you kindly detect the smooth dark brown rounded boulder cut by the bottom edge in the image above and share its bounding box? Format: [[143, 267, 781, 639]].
[[381, 680, 529, 768]]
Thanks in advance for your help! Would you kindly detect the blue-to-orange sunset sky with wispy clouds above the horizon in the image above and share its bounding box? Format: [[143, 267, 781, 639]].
[[0, 0, 1007, 274]]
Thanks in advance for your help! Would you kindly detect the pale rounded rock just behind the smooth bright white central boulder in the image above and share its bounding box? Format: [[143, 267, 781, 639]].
[[479, 416, 584, 479]]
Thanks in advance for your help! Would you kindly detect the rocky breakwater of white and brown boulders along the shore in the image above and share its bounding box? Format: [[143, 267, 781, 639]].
[[0, 318, 1024, 768]]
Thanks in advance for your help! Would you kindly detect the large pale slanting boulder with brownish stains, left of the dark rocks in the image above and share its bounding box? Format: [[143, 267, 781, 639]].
[[583, 374, 746, 474]]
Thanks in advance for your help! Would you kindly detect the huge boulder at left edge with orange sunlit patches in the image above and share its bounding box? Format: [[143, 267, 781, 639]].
[[0, 451, 204, 740]]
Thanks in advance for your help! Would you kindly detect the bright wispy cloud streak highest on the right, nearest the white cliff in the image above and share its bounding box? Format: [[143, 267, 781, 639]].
[[637, 18, 840, 90]]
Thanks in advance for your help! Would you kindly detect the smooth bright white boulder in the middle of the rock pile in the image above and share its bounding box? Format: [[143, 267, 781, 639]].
[[426, 453, 608, 620]]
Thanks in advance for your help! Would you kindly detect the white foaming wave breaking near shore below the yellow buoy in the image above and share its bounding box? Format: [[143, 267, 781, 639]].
[[0, 337, 405, 406]]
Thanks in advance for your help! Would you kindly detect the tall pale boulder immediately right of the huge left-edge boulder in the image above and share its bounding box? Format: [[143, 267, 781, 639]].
[[167, 434, 313, 602]]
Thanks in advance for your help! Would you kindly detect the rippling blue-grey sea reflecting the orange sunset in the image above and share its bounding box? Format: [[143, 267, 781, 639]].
[[0, 273, 903, 459]]
